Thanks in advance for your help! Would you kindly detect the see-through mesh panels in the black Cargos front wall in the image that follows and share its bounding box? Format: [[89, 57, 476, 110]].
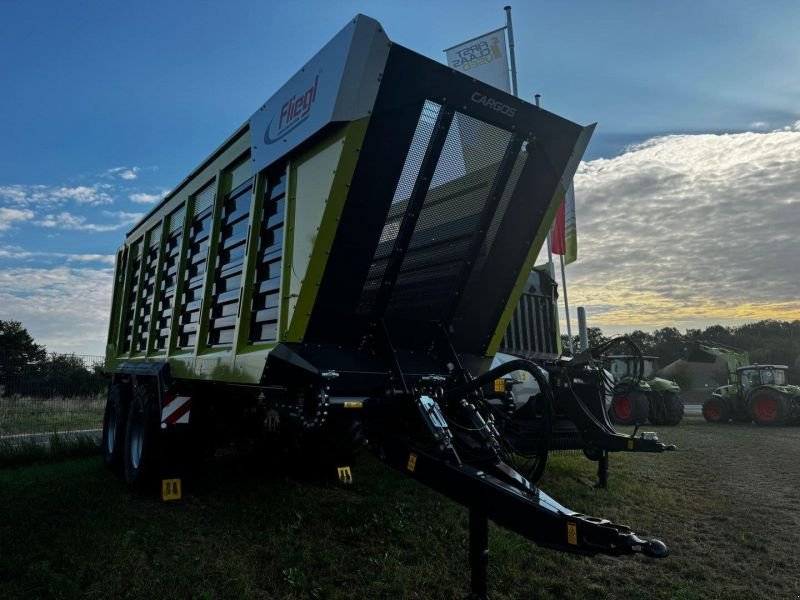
[[359, 101, 512, 320]]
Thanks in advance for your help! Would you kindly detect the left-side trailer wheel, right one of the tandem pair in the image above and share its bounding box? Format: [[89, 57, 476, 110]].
[[125, 384, 161, 488]]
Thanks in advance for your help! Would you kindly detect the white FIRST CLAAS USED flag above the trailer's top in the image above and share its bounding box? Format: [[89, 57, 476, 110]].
[[445, 27, 511, 94]]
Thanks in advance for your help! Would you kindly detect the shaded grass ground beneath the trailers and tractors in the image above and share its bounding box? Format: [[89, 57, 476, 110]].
[[0, 417, 800, 599]]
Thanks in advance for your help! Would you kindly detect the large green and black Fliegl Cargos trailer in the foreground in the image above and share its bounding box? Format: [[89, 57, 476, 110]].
[[103, 15, 667, 596]]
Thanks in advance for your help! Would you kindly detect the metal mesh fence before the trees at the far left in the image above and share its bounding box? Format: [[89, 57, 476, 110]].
[[0, 354, 108, 449]]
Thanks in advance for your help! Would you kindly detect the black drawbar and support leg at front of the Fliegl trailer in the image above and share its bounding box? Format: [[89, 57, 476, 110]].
[[371, 384, 668, 598]]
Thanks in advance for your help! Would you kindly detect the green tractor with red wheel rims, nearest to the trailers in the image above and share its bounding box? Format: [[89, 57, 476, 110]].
[[604, 354, 683, 425]]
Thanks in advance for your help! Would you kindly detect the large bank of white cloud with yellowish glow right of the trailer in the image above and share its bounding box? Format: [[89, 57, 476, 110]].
[[567, 130, 800, 329]]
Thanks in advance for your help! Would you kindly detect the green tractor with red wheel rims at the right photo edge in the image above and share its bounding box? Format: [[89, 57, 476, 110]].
[[703, 365, 800, 425]]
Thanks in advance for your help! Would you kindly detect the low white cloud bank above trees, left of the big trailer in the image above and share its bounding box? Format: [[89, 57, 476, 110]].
[[0, 266, 113, 354]]
